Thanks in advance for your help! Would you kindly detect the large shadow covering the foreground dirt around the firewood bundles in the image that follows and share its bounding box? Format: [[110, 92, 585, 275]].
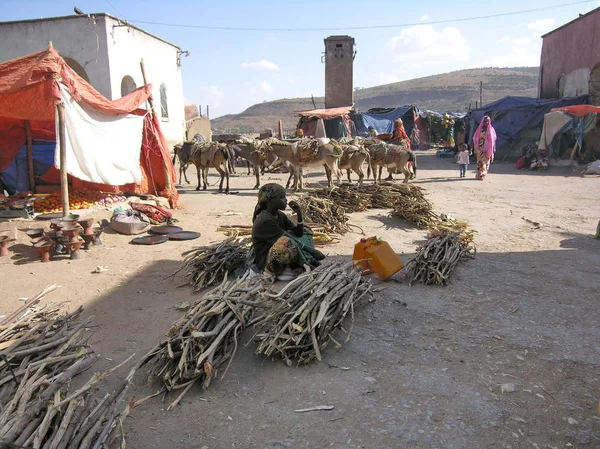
[[70, 242, 600, 449]]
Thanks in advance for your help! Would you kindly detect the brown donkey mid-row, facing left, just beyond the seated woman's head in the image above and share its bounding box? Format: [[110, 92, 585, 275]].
[[266, 139, 342, 190]]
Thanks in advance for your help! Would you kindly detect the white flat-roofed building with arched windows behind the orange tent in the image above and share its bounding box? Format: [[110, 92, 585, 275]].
[[0, 13, 185, 146]]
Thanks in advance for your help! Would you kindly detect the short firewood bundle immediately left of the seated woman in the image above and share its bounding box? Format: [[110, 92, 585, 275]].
[[175, 235, 251, 291]]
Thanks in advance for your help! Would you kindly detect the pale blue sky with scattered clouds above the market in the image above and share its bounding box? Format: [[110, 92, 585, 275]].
[[0, 0, 600, 118]]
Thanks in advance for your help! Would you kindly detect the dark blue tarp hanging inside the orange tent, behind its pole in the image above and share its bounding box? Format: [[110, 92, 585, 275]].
[[0, 141, 56, 195]]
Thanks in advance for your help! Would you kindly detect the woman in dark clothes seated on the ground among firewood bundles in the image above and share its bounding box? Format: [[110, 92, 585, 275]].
[[252, 184, 325, 281]]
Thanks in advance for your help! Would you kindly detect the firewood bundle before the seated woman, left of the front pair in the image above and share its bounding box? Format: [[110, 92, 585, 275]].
[[142, 275, 264, 409]]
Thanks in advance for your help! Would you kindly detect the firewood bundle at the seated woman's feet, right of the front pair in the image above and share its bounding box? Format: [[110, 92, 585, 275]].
[[256, 260, 372, 366]]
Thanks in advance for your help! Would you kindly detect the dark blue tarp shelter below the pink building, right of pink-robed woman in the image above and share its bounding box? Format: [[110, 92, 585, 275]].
[[467, 95, 588, 148]]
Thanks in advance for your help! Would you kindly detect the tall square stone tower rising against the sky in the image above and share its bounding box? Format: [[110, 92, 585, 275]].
[[323, 36, 355, 108]]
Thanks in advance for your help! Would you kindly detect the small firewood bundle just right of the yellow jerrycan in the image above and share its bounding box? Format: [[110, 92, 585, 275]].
[[406, 231, 475, 285]]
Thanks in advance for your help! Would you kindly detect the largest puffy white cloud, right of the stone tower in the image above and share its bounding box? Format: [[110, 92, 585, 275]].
[[388, 25, 471, 68]]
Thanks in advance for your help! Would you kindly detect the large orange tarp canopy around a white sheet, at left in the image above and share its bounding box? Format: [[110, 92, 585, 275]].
[[0, 47, 178, 206]]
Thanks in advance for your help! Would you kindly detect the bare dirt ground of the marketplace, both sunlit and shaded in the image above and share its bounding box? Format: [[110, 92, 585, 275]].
[[0, 152, 600, 449]]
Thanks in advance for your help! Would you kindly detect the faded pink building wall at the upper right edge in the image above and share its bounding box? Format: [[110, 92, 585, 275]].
[[539, 8, 600, 105]]
